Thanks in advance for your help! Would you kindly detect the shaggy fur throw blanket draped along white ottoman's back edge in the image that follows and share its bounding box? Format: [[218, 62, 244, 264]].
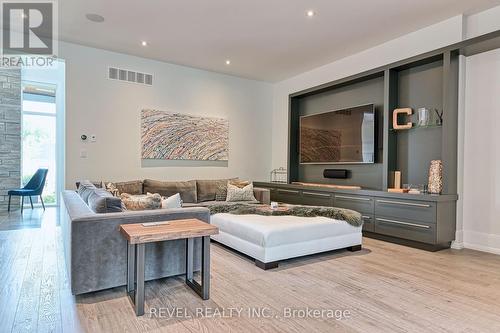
[[208, 203, 363, 227]]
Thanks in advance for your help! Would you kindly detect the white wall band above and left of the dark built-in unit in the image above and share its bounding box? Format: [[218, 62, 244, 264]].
[[272, 15, 463, 168]]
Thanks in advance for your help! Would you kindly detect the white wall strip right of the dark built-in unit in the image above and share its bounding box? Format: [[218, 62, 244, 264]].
[[462, 49, 500, 254]]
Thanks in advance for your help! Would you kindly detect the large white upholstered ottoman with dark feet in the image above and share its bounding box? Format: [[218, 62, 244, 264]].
[[210, 213, 362, 269]]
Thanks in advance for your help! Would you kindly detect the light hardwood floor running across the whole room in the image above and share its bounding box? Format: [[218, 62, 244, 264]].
[[0, 208, 500, 333]]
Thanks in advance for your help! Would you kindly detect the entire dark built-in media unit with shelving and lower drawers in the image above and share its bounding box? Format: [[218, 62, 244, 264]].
[[254, 31, 500, 251]]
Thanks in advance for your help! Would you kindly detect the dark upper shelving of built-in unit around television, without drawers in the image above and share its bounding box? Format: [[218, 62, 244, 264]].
[[288, 51, 459, 194]]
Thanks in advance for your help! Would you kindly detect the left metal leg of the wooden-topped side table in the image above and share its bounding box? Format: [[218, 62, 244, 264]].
[[127, 244, 146, 316]]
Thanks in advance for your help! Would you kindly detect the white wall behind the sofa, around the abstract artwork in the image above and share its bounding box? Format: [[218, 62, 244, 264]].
[[60, 43, 273, 188]]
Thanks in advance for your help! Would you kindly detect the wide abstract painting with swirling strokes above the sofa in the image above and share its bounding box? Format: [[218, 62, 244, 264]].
[[141, 110, 229, 161]]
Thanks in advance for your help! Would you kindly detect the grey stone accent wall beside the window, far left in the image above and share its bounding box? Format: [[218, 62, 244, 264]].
[[0, 68, 21, 211]]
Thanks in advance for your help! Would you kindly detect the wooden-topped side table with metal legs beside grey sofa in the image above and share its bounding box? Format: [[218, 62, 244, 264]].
[[120, 219, 219, 316]]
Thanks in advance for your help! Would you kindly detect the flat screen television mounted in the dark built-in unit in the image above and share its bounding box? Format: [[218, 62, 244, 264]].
[[299, 104, 375, 164]]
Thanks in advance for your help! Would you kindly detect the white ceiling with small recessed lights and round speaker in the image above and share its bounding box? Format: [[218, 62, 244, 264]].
[[59, 0, 500, 82]]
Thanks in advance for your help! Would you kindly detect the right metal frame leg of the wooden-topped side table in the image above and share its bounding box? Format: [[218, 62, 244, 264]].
[[186, 236, 210, 300]]
